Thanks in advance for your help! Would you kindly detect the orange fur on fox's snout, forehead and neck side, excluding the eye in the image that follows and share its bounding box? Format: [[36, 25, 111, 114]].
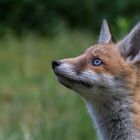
[[63, 44, 140, 129]]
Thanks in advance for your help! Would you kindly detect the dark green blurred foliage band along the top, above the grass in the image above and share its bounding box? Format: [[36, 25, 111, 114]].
[[0, 0, 140, 34]]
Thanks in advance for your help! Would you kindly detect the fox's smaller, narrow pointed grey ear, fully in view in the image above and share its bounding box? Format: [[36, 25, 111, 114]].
[[98, 19, 113, 44]]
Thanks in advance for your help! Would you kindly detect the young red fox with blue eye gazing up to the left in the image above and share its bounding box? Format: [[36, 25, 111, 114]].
[[52, 20, 140, 140]]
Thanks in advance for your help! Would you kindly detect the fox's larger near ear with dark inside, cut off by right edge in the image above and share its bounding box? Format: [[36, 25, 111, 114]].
[[118, 23, 140, 62]]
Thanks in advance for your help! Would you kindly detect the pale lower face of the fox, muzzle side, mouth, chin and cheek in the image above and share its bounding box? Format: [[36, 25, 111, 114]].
[[55, 63, 126, 101]]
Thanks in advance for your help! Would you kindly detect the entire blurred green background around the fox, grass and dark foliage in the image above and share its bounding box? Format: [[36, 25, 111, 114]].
[[0, 0, 140, 140]]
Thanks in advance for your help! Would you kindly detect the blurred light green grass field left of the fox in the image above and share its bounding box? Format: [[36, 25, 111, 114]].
[[0, 31, 96, 140]]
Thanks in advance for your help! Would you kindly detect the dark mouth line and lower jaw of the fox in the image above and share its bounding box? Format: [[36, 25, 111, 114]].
[[56, 73, 93, 88]]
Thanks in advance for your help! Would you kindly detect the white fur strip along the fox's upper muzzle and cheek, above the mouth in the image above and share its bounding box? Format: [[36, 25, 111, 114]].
[[55, 63, 119, 89]]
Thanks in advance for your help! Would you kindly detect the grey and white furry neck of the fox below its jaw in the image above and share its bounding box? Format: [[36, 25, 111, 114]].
[[87, 89, 140, 140]]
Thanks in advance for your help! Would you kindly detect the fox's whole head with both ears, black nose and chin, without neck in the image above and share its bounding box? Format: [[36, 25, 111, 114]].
[[52, 20, 140, 100]]
